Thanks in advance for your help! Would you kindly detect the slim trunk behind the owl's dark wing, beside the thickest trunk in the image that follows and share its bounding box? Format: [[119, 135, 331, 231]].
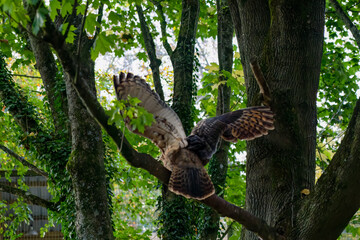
[[201, 0, 234, 240]]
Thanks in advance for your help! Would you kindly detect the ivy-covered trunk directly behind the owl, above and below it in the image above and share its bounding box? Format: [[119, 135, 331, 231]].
[[156, 0, 200, 240]]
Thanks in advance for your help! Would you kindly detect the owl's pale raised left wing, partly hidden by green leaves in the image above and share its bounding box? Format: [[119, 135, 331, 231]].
[[113, 72, 186, 152]]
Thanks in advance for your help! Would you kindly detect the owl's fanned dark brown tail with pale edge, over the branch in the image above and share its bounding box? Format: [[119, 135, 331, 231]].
[[168, 166, 215, 200]]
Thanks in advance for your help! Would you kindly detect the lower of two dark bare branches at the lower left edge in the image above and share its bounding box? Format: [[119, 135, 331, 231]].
[[0, 183, 58, 212]]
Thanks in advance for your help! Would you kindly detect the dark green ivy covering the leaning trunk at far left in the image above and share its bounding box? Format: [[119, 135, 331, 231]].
[[0, 51, 76, 239]]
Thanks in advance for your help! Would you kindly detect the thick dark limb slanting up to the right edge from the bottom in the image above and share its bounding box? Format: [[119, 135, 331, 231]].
[[294, 99, 360, 240]]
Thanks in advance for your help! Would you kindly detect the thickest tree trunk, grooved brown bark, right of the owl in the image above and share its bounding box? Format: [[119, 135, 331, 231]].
[[232, 0, 325, 239]]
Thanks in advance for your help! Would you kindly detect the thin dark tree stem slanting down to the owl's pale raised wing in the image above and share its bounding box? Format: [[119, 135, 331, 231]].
[[136, 5, 165, 101]]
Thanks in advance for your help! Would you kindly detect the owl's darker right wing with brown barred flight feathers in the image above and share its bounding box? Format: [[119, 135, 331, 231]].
[[186, 106, 274, 161]]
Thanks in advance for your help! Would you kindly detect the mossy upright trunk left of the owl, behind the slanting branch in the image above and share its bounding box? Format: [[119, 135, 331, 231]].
[[55, 39, 114, 239]]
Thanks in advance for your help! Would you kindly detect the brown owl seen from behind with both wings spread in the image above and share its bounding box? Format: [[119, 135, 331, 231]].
[[113, 72, 274, 200]]
